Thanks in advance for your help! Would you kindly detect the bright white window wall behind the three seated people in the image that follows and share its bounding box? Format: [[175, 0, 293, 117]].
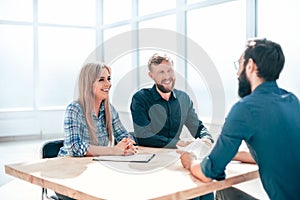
[[0, 0, 300, 198]]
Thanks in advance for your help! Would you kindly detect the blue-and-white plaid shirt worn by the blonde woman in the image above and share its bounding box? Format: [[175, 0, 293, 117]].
[[58, 101, 132, 157]]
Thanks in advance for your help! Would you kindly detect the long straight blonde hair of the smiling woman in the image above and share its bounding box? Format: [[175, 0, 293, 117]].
[[78, 63, 114, 145]]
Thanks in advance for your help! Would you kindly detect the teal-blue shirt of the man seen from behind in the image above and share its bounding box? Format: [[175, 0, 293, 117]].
[[201, 81, 300, 200]]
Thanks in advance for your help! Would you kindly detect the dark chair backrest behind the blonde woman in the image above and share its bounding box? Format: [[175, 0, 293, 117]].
[[41, 139, 64, 158]]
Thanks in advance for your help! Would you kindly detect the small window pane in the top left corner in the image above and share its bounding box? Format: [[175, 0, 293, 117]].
[[0, 0, 33, 21]]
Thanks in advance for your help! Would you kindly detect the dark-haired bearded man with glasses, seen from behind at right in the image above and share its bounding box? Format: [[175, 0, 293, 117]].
[[181, 39, 300, 200]]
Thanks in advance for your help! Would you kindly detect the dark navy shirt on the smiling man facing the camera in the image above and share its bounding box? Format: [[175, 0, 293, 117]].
[[130, 85, 213, 148]]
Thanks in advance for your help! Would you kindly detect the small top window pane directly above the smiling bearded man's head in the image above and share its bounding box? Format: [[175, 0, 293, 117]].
[[138, 0, 176, 16]]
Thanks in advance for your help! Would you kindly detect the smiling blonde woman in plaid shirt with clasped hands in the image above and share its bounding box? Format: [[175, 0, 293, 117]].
[[58, 63, 137, 157]]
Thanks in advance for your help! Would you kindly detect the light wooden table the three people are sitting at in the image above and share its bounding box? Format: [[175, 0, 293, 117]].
[[5, 148, 259, 200]]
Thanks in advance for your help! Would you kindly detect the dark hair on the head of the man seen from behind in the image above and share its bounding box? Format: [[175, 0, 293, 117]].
[[244, 39, 285, 81]]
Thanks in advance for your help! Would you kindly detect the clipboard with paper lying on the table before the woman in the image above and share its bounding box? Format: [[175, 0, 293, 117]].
[[93, 153, 155, 163]]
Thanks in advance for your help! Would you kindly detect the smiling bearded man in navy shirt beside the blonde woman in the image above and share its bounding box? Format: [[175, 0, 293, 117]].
[[130, 53, 214, 200]]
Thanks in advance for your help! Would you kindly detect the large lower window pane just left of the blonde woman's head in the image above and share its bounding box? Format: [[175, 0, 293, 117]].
[[38, 28, 96, 107]]
